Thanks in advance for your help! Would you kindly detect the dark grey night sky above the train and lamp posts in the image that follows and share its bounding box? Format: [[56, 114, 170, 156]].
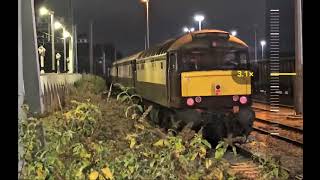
[[46, 0, 265, 55]]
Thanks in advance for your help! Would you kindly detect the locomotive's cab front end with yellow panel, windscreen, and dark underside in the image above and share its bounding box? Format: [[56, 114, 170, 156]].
[[164, 30, 255, 140]]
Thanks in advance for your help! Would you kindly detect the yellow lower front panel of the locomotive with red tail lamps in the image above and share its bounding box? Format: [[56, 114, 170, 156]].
[[181, 70, 253, 113]]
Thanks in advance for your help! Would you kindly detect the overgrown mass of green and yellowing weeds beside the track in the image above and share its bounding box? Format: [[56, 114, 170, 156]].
[[19, 76, 262, 180]]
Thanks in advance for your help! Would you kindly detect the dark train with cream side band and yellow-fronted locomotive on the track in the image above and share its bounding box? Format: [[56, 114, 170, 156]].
[[109, 29, 255, 139]]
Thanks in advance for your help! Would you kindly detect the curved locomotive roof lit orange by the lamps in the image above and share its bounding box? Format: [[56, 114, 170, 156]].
[[114, 29, 248, 64]]
